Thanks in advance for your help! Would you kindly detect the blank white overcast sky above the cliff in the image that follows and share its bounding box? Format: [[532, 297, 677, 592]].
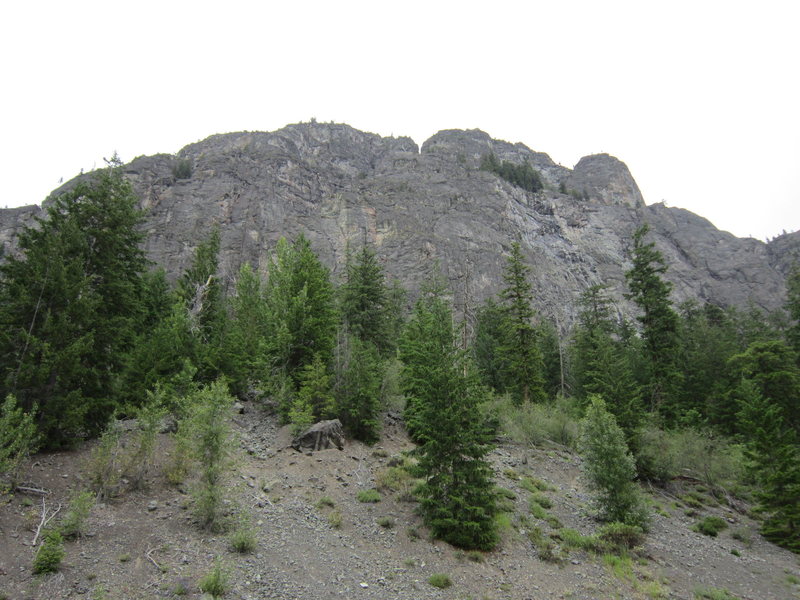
[[0, 0, 800, 239]]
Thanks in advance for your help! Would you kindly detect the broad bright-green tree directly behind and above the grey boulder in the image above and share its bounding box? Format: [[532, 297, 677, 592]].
[[264, 235, 337, 383]]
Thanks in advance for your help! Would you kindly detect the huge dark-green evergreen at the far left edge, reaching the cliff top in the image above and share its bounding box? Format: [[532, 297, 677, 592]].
[[0, 158, 146, 446]]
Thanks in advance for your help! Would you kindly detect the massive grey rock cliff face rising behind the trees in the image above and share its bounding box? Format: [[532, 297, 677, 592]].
[[0, 123, 800, 323]]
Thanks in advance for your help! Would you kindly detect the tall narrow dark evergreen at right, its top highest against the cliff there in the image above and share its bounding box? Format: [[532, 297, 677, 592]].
[[625, 224, 681, 422]]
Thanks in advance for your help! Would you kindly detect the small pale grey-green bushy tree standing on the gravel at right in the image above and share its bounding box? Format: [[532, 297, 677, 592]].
[[580, 396, 648, 527]]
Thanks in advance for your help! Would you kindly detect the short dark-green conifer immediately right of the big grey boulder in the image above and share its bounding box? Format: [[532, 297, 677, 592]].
[[336, 336, 384, 444]]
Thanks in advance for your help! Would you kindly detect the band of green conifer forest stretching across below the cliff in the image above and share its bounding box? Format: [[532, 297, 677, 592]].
[[0, 163, 800, 551]]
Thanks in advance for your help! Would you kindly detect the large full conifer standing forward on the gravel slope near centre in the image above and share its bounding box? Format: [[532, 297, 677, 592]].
[[400, 284, 497, 550]]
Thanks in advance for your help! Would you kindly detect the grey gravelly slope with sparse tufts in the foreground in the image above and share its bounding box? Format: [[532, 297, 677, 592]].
[[0, 403, 800, 600]]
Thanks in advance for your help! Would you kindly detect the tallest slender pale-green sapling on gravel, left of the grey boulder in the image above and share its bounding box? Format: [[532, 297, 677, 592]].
[[186, 380, 233, 531]]
